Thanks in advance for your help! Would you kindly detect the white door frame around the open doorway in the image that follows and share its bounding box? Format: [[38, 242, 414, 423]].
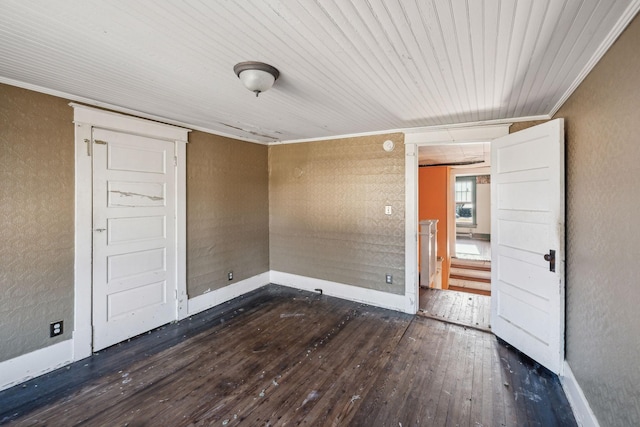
[[404, 123, 511, 314]]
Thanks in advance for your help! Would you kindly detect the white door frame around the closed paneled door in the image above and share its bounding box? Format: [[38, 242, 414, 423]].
[[69, 103, 190, 360]]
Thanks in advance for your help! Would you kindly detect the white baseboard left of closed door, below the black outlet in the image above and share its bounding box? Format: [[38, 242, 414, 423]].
[[0, 340, 73, 390]]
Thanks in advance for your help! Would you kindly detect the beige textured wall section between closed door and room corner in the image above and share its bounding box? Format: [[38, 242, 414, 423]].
[[187, 131, 269, 298]]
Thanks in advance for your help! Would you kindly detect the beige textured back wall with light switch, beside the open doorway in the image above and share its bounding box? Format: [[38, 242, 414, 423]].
[[269, 134, 405, 294]]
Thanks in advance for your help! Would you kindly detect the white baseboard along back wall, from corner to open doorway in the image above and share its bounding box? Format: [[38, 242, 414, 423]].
[[271, 270, 415, 314]]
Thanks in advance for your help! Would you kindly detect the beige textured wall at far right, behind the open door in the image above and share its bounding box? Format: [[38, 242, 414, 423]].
[[556, 14, 640, 427]]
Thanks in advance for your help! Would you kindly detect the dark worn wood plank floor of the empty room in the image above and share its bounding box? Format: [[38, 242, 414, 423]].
[[0, 285, 576, 427]]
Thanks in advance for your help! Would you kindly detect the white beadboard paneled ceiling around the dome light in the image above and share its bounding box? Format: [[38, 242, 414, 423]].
[[0, 0, 640, 143]]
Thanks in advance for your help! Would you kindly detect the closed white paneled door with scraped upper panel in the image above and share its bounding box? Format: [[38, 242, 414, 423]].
[[92, 129, 177, 351]]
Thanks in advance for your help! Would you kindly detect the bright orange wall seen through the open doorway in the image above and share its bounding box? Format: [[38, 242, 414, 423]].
[[418, 166, 451, 289]]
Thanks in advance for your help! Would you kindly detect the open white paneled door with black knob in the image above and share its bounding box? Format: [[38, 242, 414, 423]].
[[491, 119, 565, 373]]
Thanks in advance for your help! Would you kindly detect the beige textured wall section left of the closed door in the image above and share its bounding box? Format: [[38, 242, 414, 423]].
[[0, 84, 74, 361]]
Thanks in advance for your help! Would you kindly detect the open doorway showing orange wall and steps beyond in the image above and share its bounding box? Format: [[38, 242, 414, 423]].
[[418, 142, 491, 330]]
